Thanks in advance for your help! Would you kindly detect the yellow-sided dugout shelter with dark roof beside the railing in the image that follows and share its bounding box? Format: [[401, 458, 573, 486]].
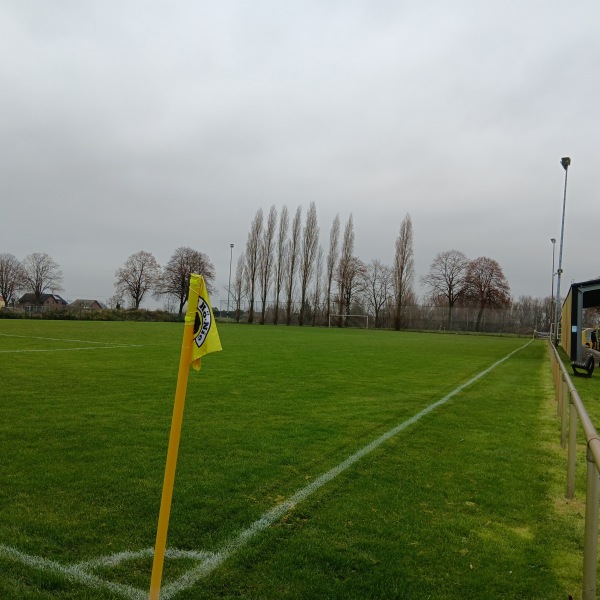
[[560, 279, 600, 362]]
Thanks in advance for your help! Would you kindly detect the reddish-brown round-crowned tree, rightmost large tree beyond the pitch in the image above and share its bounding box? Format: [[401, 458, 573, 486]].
[[465, 256, 510, 331]]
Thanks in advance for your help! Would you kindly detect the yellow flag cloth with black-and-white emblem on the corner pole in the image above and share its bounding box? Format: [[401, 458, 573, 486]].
[[185, 273, 222, 371]]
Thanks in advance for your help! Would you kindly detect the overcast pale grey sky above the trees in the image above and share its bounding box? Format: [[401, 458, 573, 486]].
[[0, 0, 600, 306]]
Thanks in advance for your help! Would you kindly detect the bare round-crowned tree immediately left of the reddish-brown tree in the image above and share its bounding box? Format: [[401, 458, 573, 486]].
[[422, 250, 469, 329]]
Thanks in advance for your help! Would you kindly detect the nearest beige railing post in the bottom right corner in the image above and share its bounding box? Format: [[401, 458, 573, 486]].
[[582, 442, 600, 600]]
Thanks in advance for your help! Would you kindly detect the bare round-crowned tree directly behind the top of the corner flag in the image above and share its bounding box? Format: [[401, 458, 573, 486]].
[[154, 247, 215, 317]]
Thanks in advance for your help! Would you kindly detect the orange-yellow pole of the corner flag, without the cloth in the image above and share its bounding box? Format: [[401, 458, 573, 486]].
[[149, 315, 194, 600]]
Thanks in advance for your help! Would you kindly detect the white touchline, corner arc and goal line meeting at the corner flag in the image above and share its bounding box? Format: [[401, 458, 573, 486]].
[[0, 340, 533, 600]]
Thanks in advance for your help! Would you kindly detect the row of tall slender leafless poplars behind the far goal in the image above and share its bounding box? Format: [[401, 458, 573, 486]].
[[230, 202, 414, 329]]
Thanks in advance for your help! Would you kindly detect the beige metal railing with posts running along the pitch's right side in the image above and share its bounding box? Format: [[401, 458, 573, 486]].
[[548, 342, 600, 600]]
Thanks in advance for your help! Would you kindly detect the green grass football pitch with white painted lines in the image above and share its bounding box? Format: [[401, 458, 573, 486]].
[[0, 321, 583, 600]]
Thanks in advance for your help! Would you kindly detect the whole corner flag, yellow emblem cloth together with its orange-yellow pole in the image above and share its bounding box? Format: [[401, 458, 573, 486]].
[[149, 273, 222, 600]]
